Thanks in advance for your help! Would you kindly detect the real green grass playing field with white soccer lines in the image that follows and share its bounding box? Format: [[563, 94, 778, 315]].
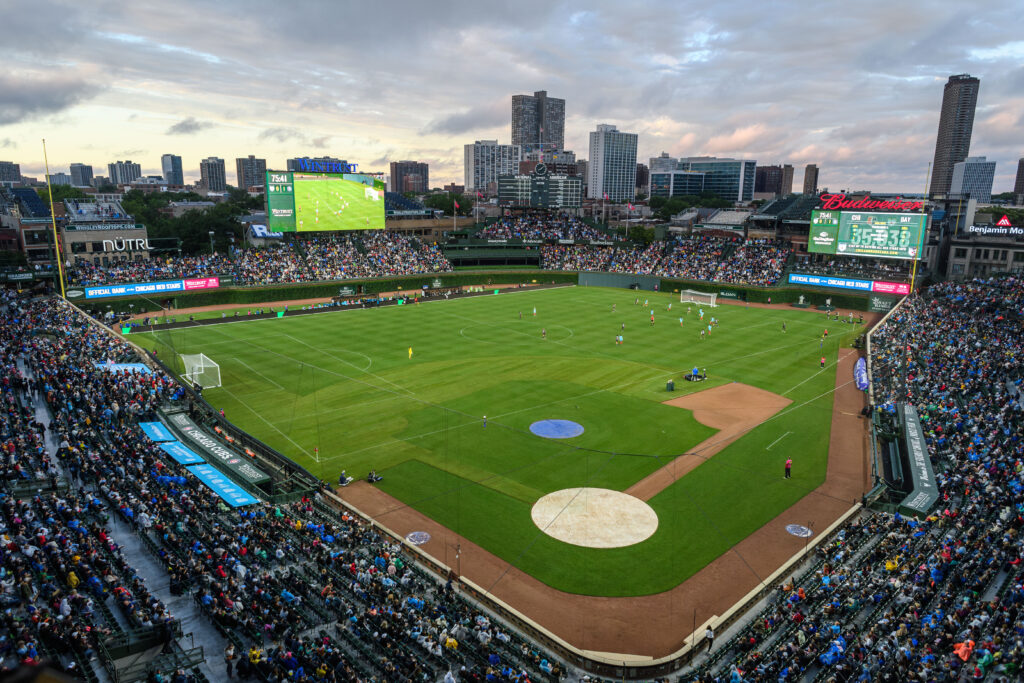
[[132, 288, 861, 596]]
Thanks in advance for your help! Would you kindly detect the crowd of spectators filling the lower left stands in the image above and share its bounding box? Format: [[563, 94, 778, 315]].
[[0, 299, 563, 682]]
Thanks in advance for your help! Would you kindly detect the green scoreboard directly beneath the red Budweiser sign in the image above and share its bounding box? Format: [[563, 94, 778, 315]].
[[807, 209, 927, 259]]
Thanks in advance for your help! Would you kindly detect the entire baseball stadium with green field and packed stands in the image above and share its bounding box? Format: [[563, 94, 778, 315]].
[[0, 184, 1024, 681]]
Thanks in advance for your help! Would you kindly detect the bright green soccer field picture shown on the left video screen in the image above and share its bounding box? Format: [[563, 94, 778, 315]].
[[295, 173, 384, 232]]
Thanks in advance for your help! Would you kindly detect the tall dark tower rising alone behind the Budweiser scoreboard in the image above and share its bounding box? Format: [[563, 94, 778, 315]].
[[929, 74, 981, 196]]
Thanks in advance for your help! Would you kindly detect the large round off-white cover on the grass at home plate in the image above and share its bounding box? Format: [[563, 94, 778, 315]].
[[530, 487, 657, 548]]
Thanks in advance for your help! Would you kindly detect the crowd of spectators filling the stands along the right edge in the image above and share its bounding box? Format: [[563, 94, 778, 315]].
[[689, 280, 1024, 682]]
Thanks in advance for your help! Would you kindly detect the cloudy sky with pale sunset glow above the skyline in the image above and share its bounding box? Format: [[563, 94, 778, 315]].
[[0, 0, 1024, 193]]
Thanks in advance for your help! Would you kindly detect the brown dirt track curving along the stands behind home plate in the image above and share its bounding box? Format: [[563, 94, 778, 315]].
[[338, 349, 870, 657]]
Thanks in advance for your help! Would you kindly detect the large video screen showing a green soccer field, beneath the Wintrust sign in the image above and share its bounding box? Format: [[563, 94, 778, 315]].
[[266, 171, 384, 232]]
